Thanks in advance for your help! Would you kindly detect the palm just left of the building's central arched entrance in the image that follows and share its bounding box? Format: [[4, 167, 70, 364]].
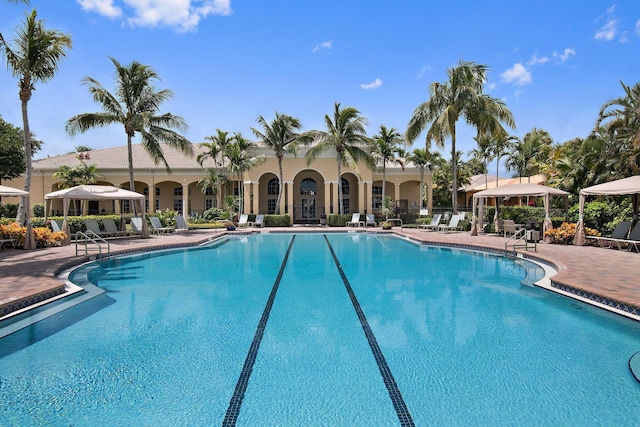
[[251, 111, 313, 215]]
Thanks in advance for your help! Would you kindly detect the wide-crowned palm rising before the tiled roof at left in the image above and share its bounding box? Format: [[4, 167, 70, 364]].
[[65, 58, 193, 197]]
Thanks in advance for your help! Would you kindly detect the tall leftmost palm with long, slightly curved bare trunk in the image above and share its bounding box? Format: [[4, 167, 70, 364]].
[[0, 9, 71, 223]]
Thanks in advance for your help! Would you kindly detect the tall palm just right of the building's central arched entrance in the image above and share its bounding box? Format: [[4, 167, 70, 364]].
[[306, 102, 374, 215]]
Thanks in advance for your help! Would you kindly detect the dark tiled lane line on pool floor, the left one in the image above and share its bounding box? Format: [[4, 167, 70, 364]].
[[222, 235, 296, 427]]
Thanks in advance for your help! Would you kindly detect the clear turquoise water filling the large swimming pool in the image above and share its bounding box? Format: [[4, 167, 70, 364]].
[[0, 233, 640, 427]]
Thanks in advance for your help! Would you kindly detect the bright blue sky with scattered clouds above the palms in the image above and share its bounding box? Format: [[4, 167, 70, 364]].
[[0, 0, 640, 166]]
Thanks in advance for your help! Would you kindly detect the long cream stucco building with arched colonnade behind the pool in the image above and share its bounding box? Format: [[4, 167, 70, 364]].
[[4, 144, 432, 223]]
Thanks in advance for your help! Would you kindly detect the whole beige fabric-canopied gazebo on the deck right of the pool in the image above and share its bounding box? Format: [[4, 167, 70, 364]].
[[471, 183, 569, 236]]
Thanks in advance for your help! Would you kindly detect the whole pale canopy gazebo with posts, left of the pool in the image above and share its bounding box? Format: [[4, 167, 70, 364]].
[[44, 185, 149, 245]]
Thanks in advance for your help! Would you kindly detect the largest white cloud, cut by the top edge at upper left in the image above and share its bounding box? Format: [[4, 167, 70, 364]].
[[77, 0, 233, 32]]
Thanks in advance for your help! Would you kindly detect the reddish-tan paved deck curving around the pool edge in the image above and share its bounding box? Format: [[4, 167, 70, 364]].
[[0, 226, 640, 320]]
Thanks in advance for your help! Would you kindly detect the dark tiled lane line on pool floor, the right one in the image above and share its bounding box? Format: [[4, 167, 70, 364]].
[[324, 235, 415, 427]]
